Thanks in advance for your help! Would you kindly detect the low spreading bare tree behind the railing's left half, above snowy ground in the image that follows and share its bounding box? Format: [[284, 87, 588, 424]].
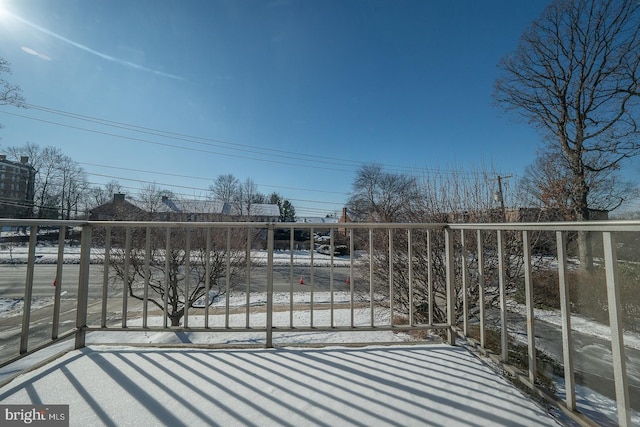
[[105, 228, 247, 326]]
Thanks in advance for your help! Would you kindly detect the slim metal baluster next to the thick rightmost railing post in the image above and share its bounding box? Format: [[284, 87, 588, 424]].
[[556, 231, 576, 411]]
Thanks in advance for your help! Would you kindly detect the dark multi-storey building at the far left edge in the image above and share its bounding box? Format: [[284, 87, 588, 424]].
[[0, 154, 36, 218]]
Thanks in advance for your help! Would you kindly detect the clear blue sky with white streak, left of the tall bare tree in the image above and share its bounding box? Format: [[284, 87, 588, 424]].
[[0, 0, 560, 216]]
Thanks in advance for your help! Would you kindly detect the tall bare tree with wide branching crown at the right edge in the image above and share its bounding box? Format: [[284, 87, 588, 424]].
[[495, 0, 640, 266]]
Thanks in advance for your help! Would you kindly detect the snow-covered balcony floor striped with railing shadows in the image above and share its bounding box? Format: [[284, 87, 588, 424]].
[[0, 344, 558, 427]]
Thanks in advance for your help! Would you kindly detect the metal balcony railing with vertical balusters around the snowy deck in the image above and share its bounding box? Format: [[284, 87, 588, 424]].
[[0, 219, 640, 425]]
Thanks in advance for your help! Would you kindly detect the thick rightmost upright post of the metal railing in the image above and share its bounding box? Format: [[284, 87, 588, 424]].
[[602, 232, 631, 427]]
